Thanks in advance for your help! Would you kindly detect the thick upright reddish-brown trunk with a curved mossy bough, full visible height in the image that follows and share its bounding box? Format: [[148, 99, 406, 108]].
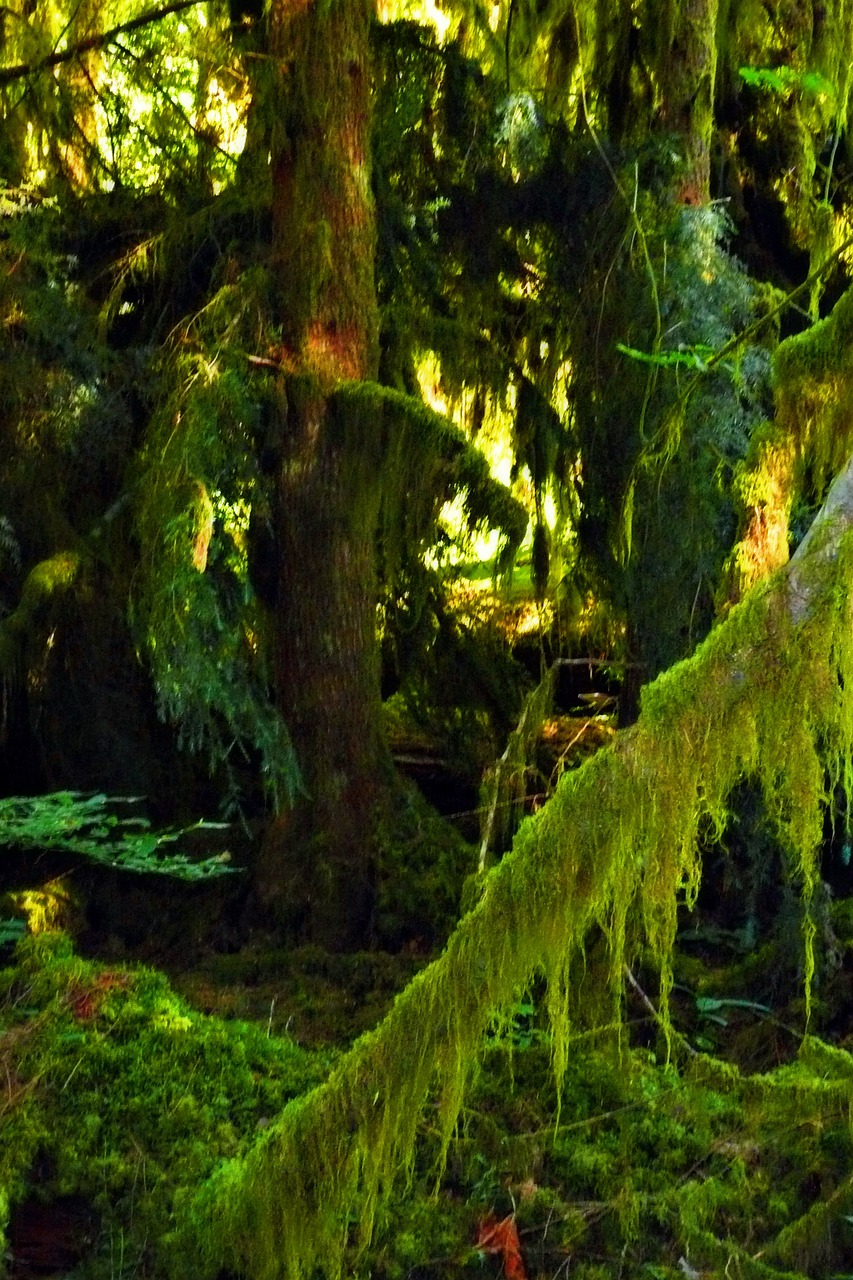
[[249, 0, 391, 946]]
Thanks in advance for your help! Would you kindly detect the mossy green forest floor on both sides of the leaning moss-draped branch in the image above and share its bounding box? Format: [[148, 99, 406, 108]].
[[0, 900, 853, 1280]]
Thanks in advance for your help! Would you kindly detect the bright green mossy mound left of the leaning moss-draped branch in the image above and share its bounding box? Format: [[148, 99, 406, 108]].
[[0, 933, 329, 1277]]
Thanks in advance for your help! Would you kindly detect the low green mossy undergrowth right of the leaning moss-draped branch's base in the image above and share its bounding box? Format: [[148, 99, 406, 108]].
[[368, 1034, 853, 1280]]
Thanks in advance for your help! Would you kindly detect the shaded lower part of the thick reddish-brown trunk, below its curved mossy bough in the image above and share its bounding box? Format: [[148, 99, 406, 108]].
[[259, 390, 392, 948]]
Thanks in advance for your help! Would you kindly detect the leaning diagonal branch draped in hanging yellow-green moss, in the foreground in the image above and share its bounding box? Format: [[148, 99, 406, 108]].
[[167, 460, 853, 1280]]
